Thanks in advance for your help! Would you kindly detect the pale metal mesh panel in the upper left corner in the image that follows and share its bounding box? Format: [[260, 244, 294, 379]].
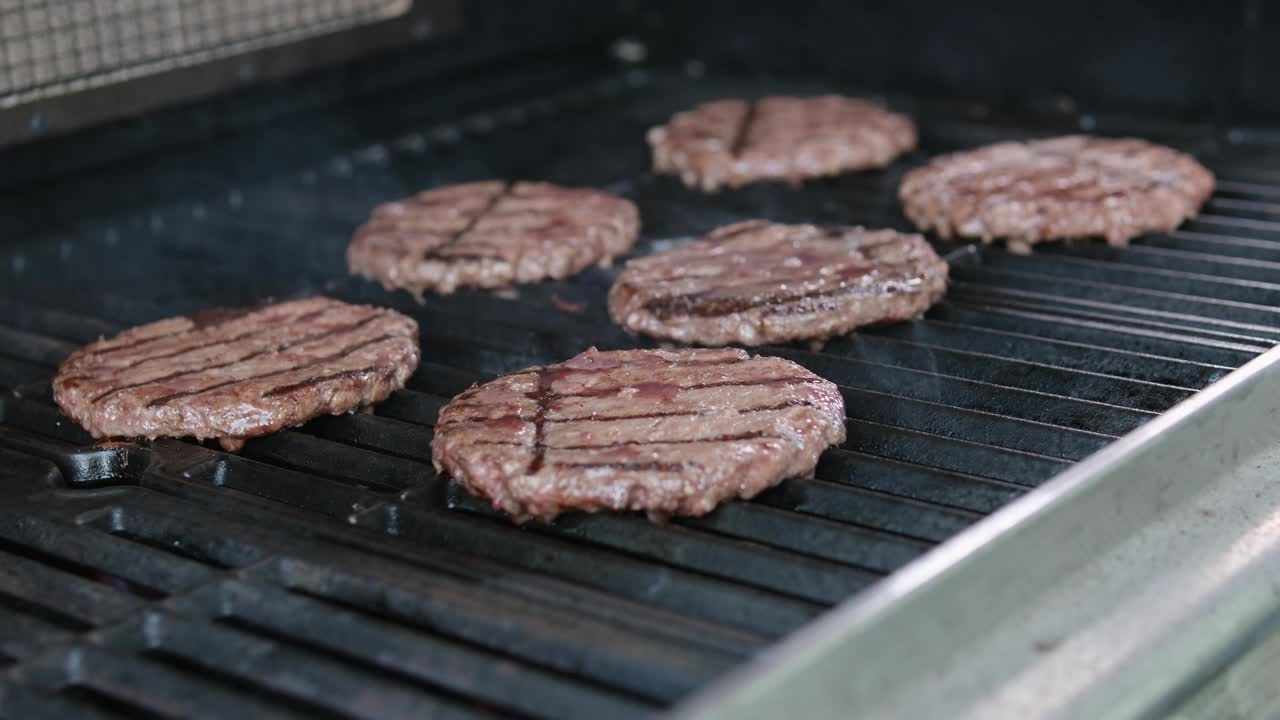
[[0, 0, 412, 108]]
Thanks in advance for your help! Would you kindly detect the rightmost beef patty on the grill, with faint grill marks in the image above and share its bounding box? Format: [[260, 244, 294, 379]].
[[899, 136, 1213, 252]]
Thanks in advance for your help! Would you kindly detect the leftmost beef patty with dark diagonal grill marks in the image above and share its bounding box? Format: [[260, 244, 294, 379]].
[[54, 297, 419, 451]]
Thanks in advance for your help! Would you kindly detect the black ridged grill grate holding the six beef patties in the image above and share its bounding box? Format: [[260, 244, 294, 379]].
[[0, 67, 1280, 719]]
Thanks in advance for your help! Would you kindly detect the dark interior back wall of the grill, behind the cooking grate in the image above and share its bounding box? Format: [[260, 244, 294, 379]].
[[0, 0, 1280, 188]]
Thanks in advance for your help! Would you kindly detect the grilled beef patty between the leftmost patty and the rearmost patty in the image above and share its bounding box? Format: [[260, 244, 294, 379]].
[[347, 182, 640, 295]]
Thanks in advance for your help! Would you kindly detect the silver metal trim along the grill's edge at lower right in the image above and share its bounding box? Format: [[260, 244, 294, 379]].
[[671, 348, 1280, 720]]
